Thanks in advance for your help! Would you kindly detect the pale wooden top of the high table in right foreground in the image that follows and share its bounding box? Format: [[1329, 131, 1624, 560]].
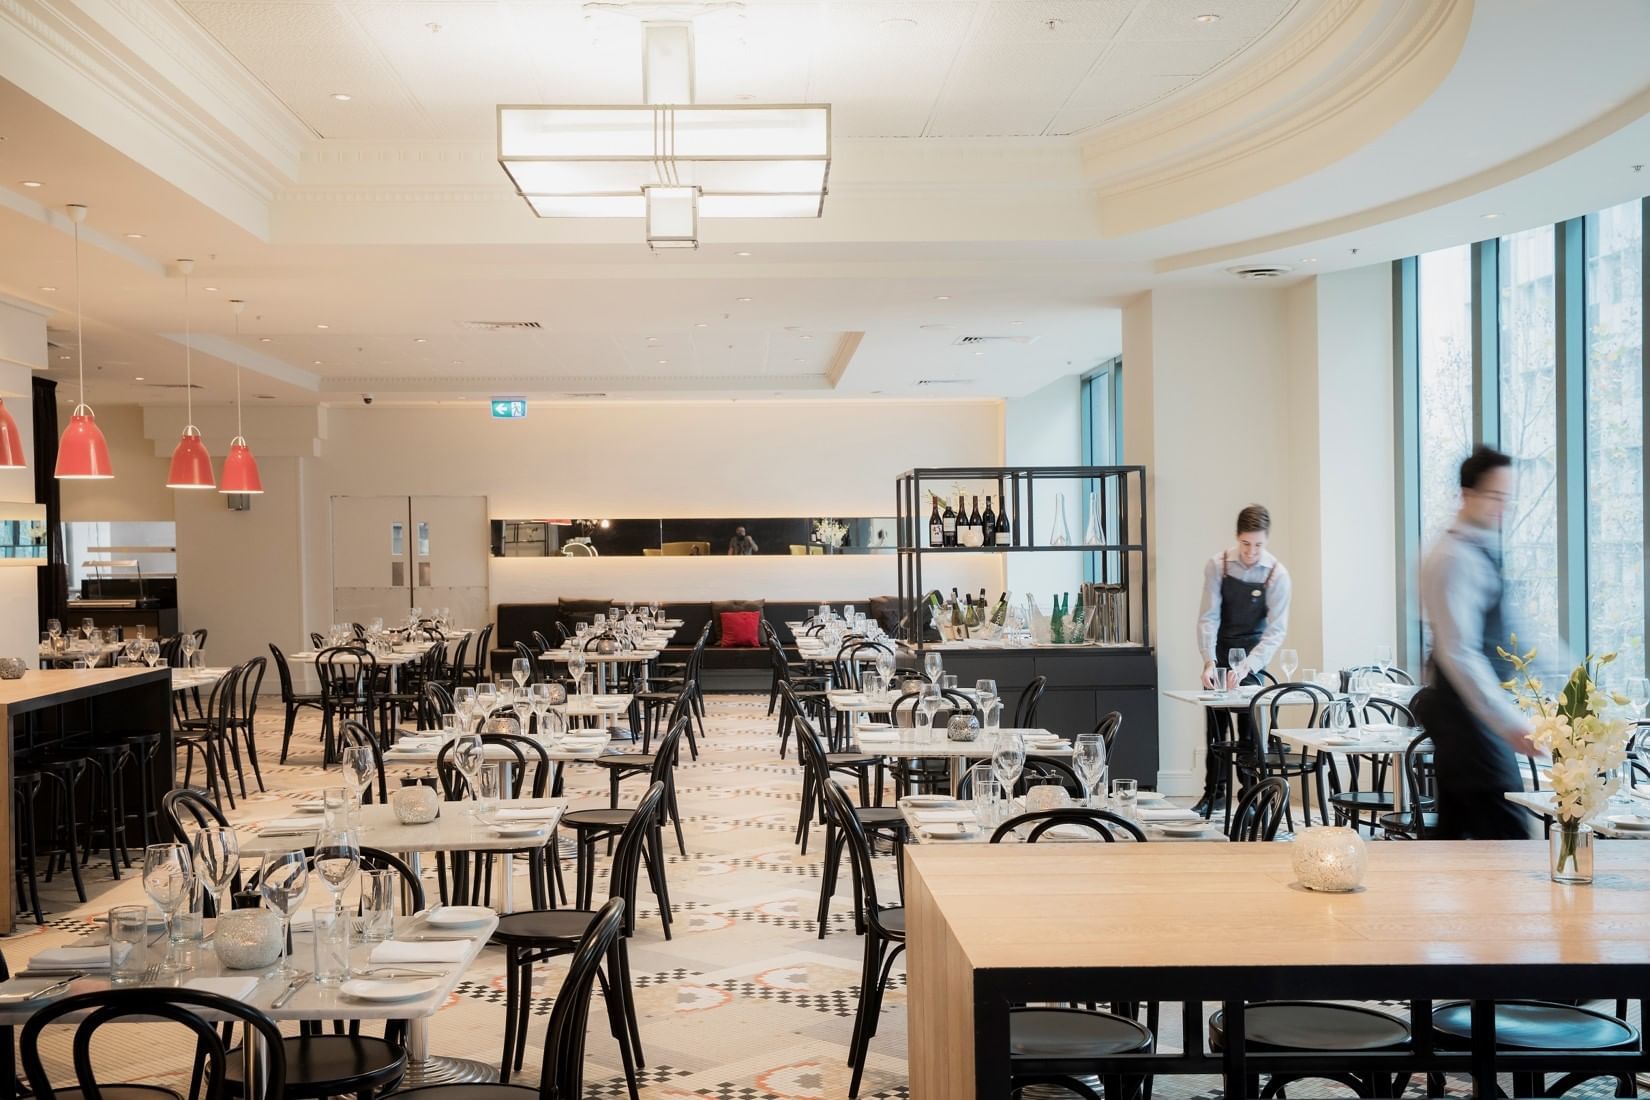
[[906, 841, 1650, 970]]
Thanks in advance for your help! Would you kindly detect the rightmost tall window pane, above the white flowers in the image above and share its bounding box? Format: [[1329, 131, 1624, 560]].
[[1584, 203, 1645, 676]]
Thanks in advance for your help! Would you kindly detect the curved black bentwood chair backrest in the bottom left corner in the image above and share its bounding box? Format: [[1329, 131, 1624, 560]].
[[18, 986, 287, 1100]]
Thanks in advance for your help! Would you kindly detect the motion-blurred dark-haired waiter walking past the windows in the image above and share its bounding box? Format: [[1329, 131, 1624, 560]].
[[1412, 447, 1535, 839]]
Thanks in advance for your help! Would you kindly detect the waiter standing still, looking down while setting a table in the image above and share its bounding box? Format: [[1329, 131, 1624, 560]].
[[1196, 505, 1290, 813]]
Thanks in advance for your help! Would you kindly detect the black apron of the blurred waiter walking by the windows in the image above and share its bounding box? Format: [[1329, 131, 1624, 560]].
[[1411, 534, 1530, 839]]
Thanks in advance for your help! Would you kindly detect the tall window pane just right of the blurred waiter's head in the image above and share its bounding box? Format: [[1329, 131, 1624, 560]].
[[1498, 226, 1557, 646]]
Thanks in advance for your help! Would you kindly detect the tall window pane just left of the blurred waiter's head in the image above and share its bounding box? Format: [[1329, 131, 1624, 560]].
[[1416, 244, 1472, 546]]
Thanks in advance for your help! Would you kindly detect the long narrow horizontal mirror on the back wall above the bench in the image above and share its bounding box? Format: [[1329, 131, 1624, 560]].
[[492, 516, 896, 557]]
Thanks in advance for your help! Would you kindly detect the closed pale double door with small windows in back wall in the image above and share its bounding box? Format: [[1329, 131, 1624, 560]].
[[332, 496, 488, 627]]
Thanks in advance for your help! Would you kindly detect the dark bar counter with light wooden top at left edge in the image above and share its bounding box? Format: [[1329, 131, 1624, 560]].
[[0, 668, 172, 933]]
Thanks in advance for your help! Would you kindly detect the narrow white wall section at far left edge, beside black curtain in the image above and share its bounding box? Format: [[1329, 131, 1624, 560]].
[[0, 291, 46, 668]]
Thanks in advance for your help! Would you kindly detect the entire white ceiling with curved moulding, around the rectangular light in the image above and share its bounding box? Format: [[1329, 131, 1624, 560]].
[[0, 0, 1650, 402]]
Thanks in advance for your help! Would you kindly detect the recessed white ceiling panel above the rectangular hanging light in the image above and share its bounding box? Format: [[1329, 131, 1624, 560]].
[[183, 0, 1325, 140]]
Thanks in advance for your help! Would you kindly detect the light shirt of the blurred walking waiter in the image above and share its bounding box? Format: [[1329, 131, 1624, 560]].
[[1421, 519, 1530, 737]]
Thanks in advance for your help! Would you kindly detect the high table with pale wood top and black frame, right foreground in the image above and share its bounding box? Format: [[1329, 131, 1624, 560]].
[[904, 841, 1650, 1100]]
